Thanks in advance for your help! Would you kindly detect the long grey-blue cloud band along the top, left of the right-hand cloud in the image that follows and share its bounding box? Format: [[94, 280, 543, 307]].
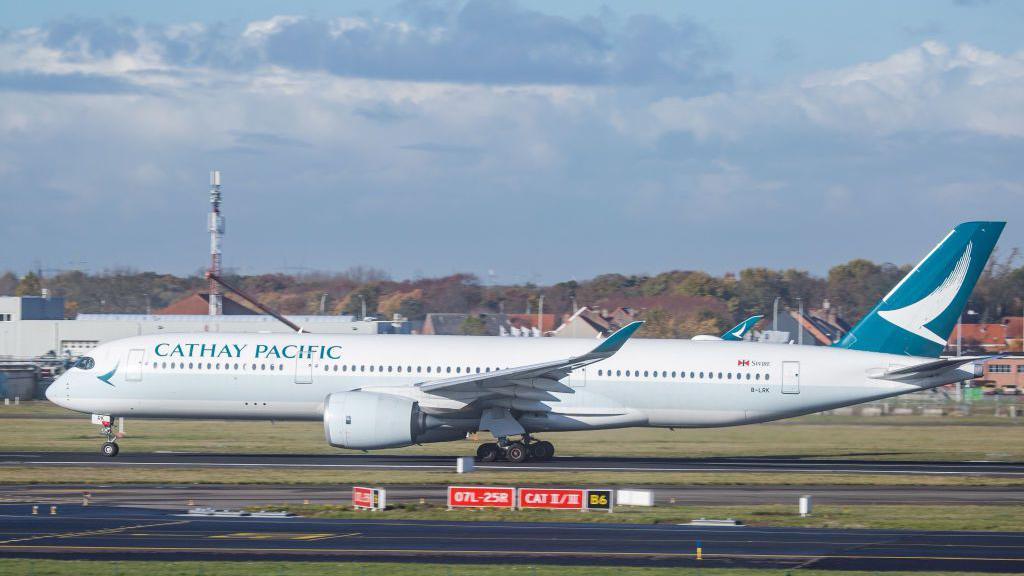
[[6, 0, 730, 92]]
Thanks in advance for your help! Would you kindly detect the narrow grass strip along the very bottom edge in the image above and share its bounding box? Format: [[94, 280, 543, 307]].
[[0, 560, 1015, 576]]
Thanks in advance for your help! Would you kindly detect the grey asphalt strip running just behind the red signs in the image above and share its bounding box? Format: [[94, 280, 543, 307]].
[[0, 484, 1024, 509]]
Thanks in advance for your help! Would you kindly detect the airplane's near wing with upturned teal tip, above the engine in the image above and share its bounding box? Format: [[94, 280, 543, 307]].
[[417, 321, 643, 394]]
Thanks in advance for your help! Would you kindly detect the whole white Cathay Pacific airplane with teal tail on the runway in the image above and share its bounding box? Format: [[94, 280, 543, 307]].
[[46, 221, 1006, 462]]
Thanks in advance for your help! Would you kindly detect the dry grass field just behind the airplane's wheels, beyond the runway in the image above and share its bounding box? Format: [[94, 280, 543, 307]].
[[8, 402, 1024, 461]]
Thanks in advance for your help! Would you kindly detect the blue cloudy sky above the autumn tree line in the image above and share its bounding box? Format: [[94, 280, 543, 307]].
[[0, 0, 1024, 283]]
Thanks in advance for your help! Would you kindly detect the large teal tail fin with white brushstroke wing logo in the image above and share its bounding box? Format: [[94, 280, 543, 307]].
[[836, 222, 1006, 358]]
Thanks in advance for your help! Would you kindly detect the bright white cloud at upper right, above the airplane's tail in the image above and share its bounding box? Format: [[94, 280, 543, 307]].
[[650, 41, 1024, 138]]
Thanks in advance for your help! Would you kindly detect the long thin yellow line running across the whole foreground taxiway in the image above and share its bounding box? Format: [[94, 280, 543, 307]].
[[0, 544, 1024, 563]]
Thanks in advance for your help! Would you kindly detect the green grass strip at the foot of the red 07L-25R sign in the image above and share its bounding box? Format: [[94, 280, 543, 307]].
[[253, 503, 1024, 532]]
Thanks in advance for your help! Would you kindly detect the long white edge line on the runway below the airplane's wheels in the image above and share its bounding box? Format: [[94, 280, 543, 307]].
[[20, 460, 1024, 476]]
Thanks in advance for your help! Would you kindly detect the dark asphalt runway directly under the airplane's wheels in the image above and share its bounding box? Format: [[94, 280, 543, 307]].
[[8, 448, 1024, 477]]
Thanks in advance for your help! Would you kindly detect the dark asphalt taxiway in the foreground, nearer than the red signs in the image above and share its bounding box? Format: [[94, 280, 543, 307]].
[[0, 504, 1024, 572]]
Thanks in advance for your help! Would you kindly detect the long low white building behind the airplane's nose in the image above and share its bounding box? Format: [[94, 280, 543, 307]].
[[0, 297, 379, 360]]
